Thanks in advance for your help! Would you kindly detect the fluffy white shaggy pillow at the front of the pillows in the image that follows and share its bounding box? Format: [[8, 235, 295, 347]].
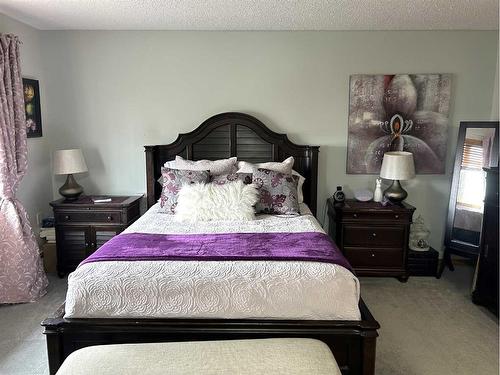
[[174, 180, 259, 223]]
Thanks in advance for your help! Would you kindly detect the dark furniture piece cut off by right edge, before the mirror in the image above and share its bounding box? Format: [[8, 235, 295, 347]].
[[472, 167, 499, 315]]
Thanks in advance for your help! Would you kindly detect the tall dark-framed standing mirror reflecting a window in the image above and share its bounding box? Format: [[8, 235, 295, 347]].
[[444, 121, 498, 270]]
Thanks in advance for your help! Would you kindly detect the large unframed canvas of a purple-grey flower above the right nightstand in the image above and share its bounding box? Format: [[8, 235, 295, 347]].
[[347, 74, 451, 174]]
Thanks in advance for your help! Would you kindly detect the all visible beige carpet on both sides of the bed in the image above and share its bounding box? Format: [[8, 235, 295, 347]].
[[0, 266, 498, 375]]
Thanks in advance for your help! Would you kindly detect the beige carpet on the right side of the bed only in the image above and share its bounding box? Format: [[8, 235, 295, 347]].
[[361, 265, 498, 375]]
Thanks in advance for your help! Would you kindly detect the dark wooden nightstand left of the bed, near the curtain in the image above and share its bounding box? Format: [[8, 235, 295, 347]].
[[50, 196, 142, 277]]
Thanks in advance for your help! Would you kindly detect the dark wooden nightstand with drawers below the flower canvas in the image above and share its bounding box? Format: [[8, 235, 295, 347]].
[[327, 199, 415, 281]]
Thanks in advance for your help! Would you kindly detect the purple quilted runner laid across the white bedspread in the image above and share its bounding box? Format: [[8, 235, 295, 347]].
[[81, 232, 352, 271]]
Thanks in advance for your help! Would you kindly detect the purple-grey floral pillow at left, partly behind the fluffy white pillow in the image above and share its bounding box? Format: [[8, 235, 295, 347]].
[[159, 168, 210, 214]]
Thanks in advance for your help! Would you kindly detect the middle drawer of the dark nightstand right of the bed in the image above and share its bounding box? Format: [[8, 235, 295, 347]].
[[343, 224, 405, 248]]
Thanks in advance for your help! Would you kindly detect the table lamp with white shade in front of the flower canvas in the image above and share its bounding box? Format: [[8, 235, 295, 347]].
[[380, 151, 415, 203]]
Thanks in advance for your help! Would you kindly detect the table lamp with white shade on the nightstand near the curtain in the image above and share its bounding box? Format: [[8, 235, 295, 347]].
[[54, 149, 88, 201]]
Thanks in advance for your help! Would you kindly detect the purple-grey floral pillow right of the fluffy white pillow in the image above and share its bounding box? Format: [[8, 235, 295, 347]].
[[252, 168, 299, 215]]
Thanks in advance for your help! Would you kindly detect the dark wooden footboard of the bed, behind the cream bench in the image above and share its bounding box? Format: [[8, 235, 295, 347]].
[[42, 300, 380, 375]]
